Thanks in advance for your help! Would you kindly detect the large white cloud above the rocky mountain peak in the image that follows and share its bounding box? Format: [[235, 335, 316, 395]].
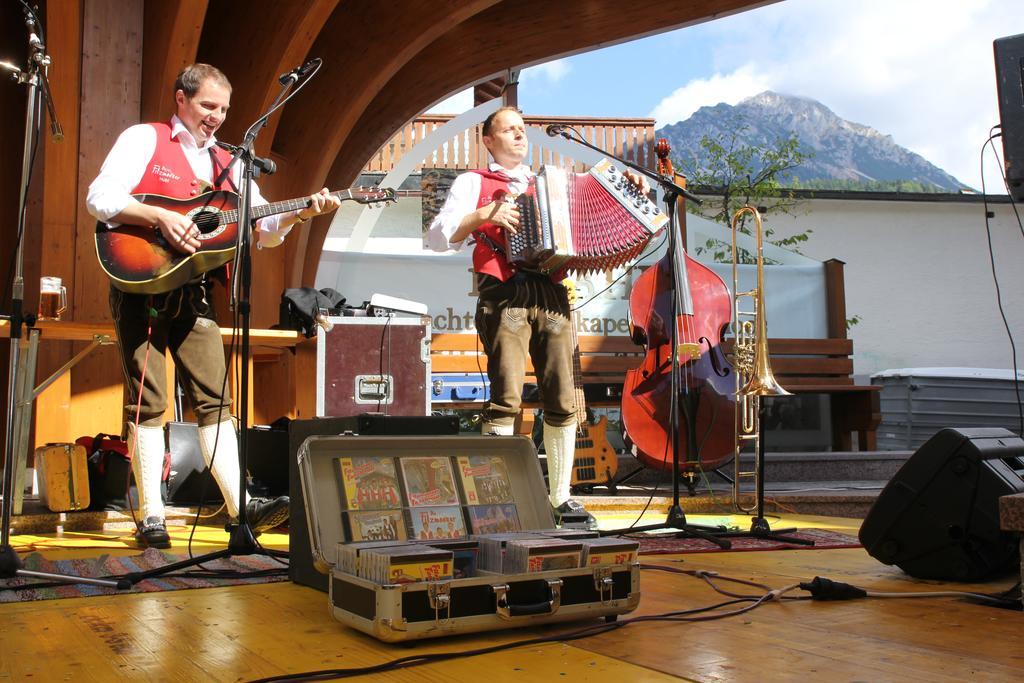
[[651, 0, 1024, 187]]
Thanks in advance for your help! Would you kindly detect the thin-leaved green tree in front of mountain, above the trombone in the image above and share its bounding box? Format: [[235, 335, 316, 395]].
[[677, 120, 813, 263]]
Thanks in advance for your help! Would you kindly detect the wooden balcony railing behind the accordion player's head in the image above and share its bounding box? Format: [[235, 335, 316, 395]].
[[365, 115, 655, 173]]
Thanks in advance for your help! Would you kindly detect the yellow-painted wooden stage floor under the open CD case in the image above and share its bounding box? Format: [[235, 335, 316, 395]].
[[0, 516, 1024, 683]]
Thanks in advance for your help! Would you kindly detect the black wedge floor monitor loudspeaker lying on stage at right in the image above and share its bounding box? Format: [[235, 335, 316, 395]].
[[860, 428, 1024, 581]]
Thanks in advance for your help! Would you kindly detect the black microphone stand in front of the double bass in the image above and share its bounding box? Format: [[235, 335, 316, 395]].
[[547, 126, 732, 550]]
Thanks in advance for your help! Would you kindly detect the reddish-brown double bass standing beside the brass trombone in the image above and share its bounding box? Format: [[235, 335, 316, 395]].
[[622, 138, 735, 495]]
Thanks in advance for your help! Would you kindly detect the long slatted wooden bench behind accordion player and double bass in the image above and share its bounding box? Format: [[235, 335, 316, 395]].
[[430, 333, 882, 451]]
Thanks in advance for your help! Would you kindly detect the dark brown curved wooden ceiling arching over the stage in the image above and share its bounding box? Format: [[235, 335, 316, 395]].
[[125, 0, 767, 291]]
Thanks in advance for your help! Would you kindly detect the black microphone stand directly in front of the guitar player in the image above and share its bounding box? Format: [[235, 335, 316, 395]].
[[117, 59, 321, 585]]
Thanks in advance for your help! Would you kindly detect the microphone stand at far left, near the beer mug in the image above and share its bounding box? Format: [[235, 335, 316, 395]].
[[0, 0, 124, 589]]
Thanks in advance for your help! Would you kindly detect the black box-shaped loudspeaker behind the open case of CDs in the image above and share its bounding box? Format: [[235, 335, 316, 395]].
[[288, 413, 459, 593]]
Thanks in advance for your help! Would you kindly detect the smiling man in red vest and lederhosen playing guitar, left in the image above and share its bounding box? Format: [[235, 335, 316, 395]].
[[86, 63, 340, 548]]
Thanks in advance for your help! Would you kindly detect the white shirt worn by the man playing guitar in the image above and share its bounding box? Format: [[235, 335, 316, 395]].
[[85, 116, 297, 247]]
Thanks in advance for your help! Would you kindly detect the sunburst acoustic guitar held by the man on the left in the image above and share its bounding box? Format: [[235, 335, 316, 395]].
[[96, 186, 395, 294]]
